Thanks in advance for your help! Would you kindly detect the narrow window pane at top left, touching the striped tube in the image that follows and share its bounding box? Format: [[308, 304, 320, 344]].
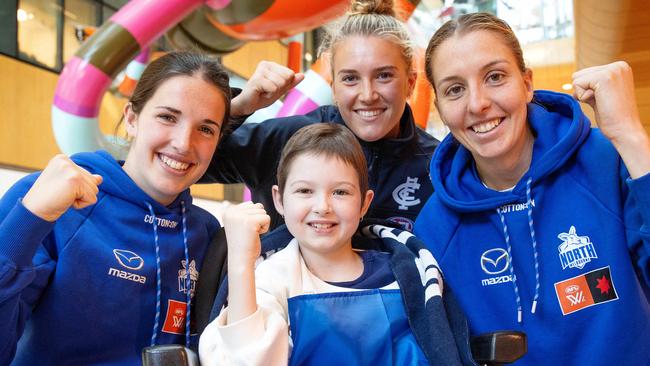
[[63, 0, 98, 62]]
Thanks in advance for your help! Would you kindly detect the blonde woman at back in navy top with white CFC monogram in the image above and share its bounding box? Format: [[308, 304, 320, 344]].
[[205, 0, 438, 230]]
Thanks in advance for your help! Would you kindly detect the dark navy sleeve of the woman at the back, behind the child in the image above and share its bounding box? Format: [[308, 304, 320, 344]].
[[200, 108, 325, 188]]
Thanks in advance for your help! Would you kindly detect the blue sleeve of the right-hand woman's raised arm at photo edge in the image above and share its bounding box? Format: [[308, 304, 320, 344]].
[[624, 173, 650, 288]]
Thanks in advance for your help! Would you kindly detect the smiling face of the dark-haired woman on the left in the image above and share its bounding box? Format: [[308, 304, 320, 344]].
[[124, 76, 225, 205]]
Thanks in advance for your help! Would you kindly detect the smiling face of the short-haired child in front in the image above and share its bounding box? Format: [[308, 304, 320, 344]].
[[273, 153, 373, 258]]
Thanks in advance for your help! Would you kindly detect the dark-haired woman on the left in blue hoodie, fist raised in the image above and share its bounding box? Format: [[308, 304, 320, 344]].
[[0, 53, 230, 365]]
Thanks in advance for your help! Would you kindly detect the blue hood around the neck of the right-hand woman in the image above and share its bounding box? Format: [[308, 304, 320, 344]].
[[431, 90, 591, 212]]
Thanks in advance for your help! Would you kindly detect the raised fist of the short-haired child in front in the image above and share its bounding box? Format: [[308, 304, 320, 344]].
[[223, 201, 271, 265]]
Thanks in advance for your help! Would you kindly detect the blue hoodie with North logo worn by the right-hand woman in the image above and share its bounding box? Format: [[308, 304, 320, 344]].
[[415, 91, 650, 365]]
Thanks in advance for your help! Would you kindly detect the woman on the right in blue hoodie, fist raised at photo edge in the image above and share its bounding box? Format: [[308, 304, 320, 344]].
[[415, 13, 650, 365]]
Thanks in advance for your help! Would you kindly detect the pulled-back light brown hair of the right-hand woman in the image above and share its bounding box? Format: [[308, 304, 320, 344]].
[[424, 13, 526, 91]]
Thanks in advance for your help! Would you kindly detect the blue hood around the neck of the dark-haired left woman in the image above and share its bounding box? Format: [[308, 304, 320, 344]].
[[71, 150, 192, 214]]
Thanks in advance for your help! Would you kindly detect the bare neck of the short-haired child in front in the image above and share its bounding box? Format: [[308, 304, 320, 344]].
[[300, 246, 363, 282]]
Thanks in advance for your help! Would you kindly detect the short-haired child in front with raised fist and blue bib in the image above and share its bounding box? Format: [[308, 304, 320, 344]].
[[199, 123, 472, 365]]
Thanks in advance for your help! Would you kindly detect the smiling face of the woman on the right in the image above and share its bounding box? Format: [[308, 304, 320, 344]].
[[431, 30, 533, 165]]
